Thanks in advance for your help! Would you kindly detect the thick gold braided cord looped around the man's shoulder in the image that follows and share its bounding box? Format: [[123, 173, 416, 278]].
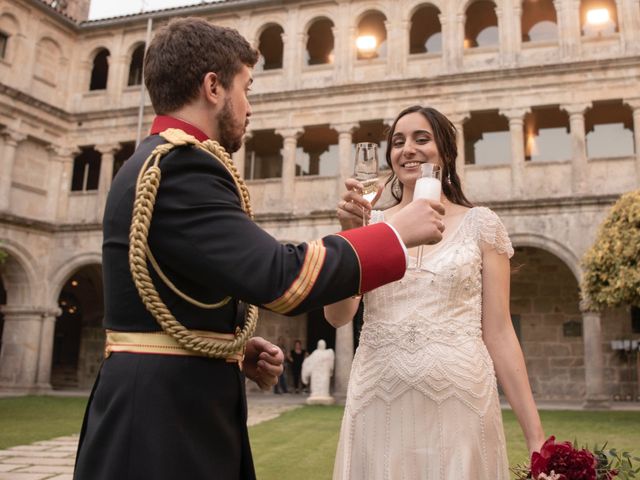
[[129, 129, 258, 358]]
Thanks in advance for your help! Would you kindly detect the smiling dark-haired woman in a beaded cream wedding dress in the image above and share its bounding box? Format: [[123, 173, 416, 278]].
[[325, 106, 544, 480]]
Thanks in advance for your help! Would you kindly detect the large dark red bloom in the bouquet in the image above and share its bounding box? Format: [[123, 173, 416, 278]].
[[531, 436, 597, 480]]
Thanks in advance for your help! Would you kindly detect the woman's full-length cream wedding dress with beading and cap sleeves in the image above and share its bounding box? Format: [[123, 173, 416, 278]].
[[333, 207, 513, 480]]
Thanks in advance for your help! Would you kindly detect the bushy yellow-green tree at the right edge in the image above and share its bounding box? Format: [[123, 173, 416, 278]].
[[582, 190, 640, 308]]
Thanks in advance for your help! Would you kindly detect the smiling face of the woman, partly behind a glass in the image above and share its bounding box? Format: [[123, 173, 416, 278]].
[[391, 112, 442, 189]]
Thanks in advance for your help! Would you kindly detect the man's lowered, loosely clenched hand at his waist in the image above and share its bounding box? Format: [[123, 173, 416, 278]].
[[243, 337, 284, 390]]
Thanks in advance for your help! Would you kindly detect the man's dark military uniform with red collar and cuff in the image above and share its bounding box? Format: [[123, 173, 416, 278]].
[[74, 116, 406, 480]]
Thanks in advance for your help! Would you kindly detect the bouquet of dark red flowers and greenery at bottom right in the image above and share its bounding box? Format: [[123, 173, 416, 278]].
[[512, 437, 640, 480]]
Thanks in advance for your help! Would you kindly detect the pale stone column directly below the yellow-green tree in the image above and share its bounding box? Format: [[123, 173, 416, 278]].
[[580, 302, 610, 409]]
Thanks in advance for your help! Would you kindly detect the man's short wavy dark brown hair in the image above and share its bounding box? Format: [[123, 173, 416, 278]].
[[144, 17, 259, 115]]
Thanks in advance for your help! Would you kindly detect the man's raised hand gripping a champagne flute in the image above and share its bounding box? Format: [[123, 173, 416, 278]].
[[387, 199, 444, 248]]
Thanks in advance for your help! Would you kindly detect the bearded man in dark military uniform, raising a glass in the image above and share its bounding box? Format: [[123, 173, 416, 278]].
[[74, 18, 442, 480]]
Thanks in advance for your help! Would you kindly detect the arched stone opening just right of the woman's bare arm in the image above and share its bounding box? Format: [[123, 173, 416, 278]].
[[510, 235, 589, 400]]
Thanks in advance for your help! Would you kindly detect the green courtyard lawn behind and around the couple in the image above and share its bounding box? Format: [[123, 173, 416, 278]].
[[0, 397, 640, 480]]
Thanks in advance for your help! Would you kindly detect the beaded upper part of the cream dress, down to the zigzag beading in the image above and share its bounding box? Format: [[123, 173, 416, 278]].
[[348, 207, 513, 413]]
